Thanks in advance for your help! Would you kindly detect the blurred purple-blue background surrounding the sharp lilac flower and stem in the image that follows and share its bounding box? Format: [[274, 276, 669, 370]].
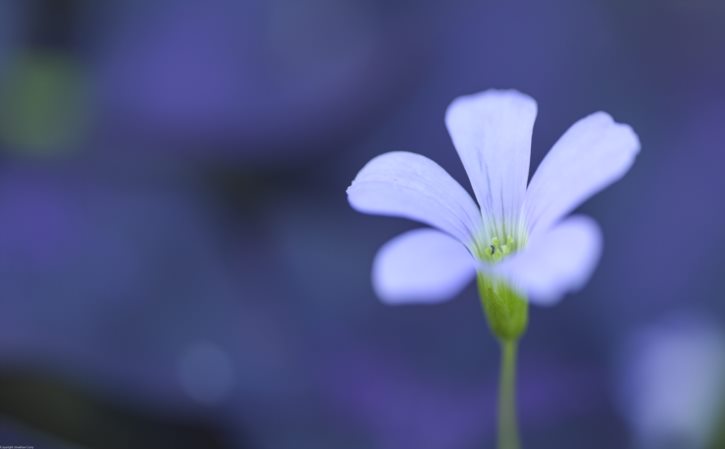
[[0, 0, 725, 449]]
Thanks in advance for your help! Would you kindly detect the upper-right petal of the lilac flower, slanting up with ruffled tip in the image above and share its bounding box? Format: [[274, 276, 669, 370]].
[[524, 112, 639, 235]]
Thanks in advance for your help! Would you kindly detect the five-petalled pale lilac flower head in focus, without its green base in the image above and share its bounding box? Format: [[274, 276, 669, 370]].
[[347, 90, 639, 304]]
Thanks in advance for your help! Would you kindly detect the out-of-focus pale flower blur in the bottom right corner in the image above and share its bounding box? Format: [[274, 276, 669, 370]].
[[616, 311, 725, 449]]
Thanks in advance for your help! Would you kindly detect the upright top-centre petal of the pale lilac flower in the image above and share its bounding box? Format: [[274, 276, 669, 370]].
[[446, 90, 537, 237]]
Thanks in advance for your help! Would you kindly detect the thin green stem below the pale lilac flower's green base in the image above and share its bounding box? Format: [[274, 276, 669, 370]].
[[498, 340, 521, 449]]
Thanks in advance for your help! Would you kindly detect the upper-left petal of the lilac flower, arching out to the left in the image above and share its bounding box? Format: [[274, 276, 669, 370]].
[[347, 151, 481, 248]]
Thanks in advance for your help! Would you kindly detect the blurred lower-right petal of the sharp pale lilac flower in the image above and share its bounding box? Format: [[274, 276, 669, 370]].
[[492, 216, 602, 305]]
